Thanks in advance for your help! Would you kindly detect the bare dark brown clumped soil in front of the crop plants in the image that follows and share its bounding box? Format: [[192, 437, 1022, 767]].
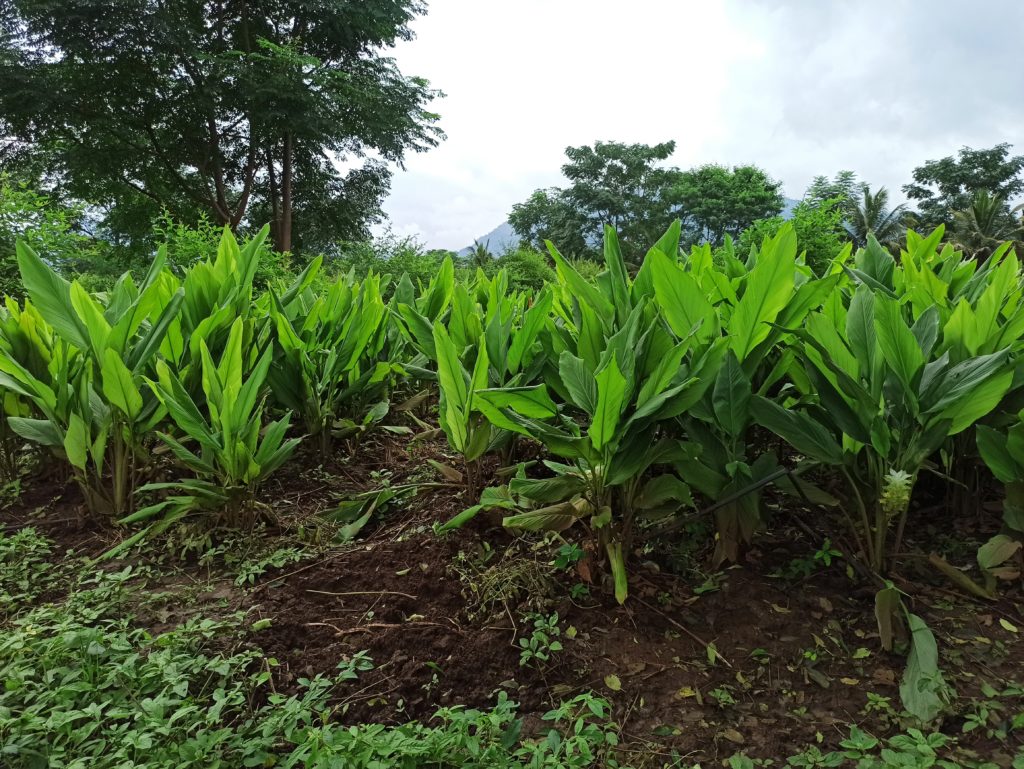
[[4, 439, 1024, 767]]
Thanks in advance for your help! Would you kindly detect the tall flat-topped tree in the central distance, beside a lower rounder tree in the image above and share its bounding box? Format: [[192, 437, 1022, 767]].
[[509, 141, 679, 259]]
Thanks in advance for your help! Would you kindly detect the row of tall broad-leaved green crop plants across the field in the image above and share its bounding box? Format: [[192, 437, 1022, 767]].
[[0, 224, 1024, 718]]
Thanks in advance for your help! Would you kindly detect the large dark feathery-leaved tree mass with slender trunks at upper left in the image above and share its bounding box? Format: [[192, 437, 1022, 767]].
[[0, 0, 441, 251]]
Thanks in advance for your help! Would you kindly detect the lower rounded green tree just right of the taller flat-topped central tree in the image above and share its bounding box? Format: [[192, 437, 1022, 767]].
[[674, 165, 782, 246]]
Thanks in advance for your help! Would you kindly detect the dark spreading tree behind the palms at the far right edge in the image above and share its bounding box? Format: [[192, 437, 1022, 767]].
[[903, 143, 1024, 227]]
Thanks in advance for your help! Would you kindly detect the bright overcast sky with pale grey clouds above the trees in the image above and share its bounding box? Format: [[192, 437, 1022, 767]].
[[376, 0, 1024, 249]]
